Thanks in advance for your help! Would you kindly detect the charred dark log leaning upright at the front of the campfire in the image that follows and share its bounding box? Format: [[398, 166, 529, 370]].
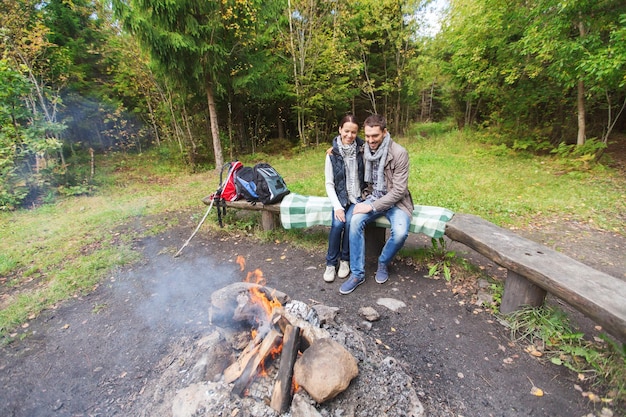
[[270, 324, 300, 413]]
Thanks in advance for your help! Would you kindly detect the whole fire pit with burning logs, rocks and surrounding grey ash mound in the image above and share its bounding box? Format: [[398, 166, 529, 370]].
[[131, 260, 424, 417]]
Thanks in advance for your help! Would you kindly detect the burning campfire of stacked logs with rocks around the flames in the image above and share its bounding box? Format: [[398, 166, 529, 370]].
[[210, 257, 358, 413]]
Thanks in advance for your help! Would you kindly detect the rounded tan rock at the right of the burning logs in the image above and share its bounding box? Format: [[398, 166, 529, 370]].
[[293, 338, 359, 404]]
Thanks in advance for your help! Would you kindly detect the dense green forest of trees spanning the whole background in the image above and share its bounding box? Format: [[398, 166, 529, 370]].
[[0, 0, 626, 210]]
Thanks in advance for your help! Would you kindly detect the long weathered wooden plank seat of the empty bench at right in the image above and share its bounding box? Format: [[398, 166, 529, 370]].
[[446, 213, 626, 341]]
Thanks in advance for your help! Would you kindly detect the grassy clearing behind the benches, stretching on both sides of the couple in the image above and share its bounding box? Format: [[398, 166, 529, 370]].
[[0, 124, 626, 340]]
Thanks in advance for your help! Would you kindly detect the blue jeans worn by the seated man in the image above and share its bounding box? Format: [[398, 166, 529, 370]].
[[350, 206, 411, 278]]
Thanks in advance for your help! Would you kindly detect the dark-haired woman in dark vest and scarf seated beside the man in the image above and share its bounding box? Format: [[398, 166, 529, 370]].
[[324, 114, 365, 282]]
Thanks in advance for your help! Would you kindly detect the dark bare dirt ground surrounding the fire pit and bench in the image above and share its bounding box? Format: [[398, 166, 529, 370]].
[[0, 213, 626, 417]]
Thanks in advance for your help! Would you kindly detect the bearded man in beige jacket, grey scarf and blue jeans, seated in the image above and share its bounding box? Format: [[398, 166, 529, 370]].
[[339, 114, 414, 294]]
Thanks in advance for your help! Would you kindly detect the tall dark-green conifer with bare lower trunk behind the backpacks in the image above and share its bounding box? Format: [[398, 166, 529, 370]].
[[113, 0, 238, 170]]
